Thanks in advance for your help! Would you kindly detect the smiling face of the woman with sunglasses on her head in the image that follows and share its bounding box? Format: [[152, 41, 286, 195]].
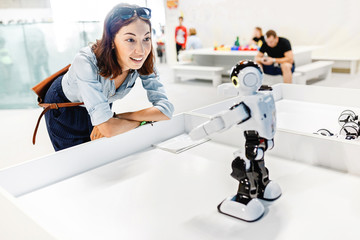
[[114, 19, 151, 71]]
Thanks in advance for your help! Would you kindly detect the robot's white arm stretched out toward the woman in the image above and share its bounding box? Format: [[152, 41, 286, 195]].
[[189, 102, 251, 140]]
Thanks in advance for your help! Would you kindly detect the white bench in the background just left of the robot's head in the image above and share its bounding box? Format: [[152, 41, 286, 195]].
[[172, 64, 224, 87]]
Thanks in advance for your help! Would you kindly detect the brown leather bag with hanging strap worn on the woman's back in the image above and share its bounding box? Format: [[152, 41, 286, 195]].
[[32, 64, 84, 144]]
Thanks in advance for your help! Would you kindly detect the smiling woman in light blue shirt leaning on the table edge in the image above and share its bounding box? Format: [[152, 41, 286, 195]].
[[44, 4, 174, 151]]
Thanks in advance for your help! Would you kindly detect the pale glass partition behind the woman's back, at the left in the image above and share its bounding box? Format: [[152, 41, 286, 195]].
[[0, 22, 102, 109]]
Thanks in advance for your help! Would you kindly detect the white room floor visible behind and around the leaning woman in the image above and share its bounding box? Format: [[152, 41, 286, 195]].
[[0, 64, 360, 168]]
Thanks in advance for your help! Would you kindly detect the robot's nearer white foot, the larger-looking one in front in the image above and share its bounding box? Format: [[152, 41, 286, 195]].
[[218, 196, 265, 222]]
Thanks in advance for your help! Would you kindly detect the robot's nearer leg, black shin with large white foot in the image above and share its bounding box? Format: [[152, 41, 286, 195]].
[[218, 157, 265, 222]]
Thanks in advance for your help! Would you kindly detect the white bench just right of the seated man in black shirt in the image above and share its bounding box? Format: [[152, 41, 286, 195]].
[[293, 61, 334, 84]]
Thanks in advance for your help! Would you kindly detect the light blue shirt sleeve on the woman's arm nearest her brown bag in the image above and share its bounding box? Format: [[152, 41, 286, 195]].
[[69, 54, 113, 126]]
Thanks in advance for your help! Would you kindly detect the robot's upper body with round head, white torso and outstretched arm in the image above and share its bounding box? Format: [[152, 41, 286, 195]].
[[189, 61, 276, 142]]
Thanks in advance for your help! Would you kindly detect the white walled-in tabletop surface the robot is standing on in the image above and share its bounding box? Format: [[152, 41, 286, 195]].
[[18, 142, 360, 240]]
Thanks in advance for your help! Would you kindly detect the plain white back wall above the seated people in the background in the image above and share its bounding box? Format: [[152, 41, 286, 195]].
[[169, 0, 360, 57]]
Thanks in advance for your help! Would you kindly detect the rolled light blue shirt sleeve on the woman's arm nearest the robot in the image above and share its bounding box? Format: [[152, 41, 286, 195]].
[[139, 73, 174, 118]]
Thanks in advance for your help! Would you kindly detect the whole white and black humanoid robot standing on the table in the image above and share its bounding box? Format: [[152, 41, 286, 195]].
[[189, 61, 281, 222]]
